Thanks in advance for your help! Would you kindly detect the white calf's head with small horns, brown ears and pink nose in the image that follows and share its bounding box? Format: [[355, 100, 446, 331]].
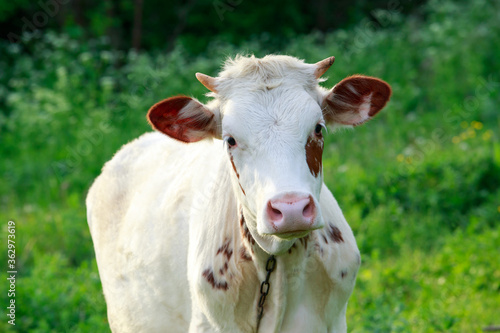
[[148, 56, 391, 254]]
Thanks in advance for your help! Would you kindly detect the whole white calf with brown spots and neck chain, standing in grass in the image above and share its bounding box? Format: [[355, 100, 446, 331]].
[[87, 56, 391, 332]]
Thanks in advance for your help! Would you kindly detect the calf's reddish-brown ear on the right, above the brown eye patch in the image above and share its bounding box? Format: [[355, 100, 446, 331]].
[[322, 75, 392, 126]]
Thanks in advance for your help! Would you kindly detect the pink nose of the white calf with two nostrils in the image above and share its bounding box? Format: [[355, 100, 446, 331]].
[[267, 194, 316, 234]]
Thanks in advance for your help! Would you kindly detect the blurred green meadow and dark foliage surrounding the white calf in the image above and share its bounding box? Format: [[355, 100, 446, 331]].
[[0, 0, 500, 332]]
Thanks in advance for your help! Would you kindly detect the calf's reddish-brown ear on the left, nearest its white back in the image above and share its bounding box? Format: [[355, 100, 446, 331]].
[[147, 96, 220, 142]]
